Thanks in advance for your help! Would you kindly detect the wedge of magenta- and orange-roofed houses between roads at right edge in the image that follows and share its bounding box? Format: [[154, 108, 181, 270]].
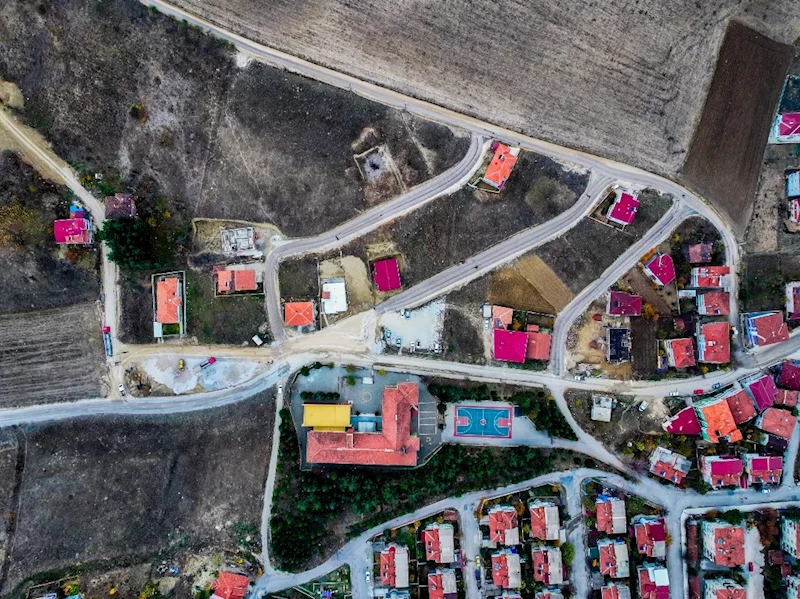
[[650, 362, 800, 489]]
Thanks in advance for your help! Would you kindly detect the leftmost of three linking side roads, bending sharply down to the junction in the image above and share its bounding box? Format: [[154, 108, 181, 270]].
[[265, 134, 486, 342]]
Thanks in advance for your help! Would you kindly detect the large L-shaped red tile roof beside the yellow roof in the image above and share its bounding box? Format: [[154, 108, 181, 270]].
[[306, 383, 419, 466]]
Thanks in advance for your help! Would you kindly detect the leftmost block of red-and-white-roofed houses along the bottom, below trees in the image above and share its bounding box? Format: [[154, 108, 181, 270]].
[[375, 522, 460, 599]]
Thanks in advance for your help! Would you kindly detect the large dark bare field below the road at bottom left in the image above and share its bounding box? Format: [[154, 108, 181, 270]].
[[3, 391, 274, 594]]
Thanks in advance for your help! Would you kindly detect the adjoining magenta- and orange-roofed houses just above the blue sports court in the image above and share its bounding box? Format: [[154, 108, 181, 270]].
[[481, 304, 553, 364]]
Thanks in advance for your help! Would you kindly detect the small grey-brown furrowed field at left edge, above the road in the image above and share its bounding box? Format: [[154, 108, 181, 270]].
[[0, 302, 105, 408]]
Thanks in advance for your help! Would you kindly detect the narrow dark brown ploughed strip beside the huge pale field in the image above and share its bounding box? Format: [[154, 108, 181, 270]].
[[683, 22, 793, 235]]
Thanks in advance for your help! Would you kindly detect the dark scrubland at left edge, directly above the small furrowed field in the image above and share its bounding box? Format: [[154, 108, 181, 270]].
[[0, 151, 100, 313]]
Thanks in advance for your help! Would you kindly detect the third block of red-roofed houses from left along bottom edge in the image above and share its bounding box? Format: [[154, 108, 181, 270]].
[[589, 489, 669, 599]]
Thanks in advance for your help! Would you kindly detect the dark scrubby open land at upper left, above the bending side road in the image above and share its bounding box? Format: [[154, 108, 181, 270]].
[[0, 0, 469, 236]]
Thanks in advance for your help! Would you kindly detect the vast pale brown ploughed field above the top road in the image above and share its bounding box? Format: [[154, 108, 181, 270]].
[[169, 0, 799, 174]]
